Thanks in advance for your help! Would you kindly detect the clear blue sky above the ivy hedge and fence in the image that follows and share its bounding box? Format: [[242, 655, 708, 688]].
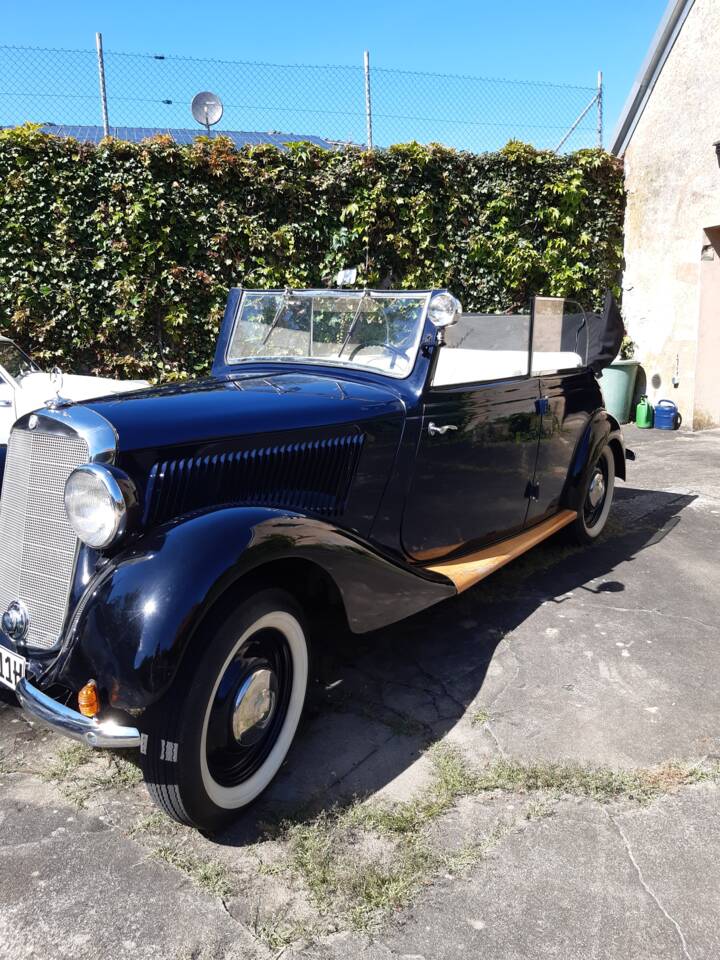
[[0, 0, 665, 147]]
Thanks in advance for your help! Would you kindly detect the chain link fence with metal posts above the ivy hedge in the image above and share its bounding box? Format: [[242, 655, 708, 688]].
[[0, 46, 602, 151]]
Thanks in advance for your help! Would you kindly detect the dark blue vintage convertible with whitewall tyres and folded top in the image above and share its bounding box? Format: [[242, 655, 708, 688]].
[[0, 289, 626, 829]]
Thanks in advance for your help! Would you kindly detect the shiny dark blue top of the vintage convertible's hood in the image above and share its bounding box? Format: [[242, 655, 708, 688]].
[[86, 373, 404, 452]]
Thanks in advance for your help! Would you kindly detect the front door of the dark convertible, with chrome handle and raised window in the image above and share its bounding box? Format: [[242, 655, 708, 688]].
[[402, 315, 540, 561]]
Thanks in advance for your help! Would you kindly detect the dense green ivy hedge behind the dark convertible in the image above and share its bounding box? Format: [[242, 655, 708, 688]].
[[0, 126, 624, 378]]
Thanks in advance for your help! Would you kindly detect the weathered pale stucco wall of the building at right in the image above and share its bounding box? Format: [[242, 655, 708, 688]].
[[623, 0, 720, 426]]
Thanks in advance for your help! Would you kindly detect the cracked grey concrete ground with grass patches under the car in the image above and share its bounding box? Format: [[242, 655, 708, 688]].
[[0, 428, 720, 960]]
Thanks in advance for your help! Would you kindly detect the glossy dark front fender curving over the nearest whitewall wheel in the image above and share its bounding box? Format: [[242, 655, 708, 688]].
[[42, 507, 455, 710]]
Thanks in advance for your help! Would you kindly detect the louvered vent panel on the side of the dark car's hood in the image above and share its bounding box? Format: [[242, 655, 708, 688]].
[[146, 434, 364, 524]]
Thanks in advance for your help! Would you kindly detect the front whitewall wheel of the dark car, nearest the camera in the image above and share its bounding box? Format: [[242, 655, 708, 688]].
[[141, 590, 309, 831]]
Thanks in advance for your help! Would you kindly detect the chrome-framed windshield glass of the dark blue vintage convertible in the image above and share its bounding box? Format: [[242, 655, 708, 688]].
[[227, 290, 430, 377]]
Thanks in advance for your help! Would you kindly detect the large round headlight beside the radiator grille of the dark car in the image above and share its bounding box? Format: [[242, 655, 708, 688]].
[[65, 463, 127, 550]]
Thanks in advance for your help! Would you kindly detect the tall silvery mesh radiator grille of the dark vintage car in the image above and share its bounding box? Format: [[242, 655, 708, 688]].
[[0, 430, 88, 649]]
